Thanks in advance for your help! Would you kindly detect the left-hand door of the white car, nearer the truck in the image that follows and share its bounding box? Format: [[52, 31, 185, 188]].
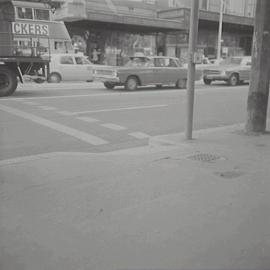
[[58, 55, 78, 81]]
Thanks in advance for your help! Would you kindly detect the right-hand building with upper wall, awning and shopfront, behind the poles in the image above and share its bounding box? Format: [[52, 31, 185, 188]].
[[158, 0, 256, 58]]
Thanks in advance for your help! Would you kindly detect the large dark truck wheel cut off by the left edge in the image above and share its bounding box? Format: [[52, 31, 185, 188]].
[[0, 66, 18, 97]]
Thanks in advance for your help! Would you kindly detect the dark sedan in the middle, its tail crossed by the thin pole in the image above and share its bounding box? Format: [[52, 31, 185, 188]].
[[94, 56, 201, 90]]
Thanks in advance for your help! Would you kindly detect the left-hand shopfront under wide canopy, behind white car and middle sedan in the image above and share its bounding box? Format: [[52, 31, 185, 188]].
[[54, 0, 185, 65]]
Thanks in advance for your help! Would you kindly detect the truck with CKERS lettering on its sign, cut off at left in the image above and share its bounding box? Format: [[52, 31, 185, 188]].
[[0, 0, 71, 97]]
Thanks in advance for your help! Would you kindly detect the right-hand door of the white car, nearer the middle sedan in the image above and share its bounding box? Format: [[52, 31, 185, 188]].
[[74, 55, 93, 81]]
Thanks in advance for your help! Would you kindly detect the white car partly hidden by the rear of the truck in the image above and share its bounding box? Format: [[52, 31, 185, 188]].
[[48, 53, 94, 83]]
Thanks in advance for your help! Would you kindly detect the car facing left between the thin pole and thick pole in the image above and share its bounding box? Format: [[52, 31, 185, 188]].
[[203, 56, 251, 86]]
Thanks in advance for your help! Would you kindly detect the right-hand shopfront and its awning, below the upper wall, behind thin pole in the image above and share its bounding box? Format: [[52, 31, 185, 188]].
[[158, 8, 254, 59]]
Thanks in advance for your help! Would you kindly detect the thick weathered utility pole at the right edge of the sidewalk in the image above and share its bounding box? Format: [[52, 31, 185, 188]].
[[246, 0, 270, 132]]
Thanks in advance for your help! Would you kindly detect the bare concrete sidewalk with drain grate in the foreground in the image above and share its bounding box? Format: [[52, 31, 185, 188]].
[[0, 126, 270, 270]]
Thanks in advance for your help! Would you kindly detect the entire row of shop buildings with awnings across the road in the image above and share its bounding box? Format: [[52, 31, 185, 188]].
[[54, 0, 255, 65]]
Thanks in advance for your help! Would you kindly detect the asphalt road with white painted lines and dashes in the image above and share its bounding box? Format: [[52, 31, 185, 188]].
[[0, 80, 268, 160]]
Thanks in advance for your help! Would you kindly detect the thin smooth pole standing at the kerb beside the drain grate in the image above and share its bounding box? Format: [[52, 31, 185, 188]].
[[185, 0, 199, 140]]
